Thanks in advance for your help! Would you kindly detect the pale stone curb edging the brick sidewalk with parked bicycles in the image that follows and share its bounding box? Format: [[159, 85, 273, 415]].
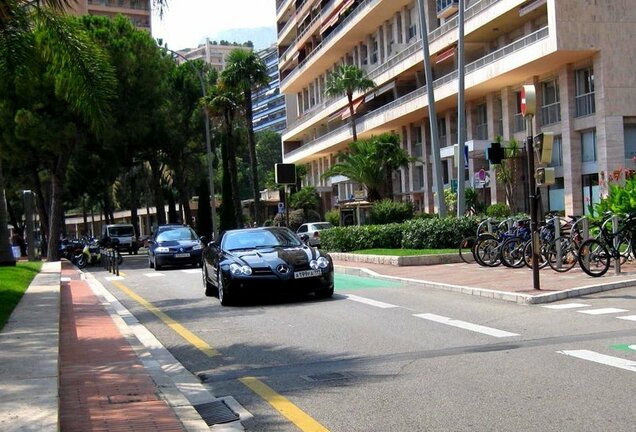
[[334, 265, 636, 304]]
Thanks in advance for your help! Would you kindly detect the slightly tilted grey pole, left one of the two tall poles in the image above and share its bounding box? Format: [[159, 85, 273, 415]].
[[417, 0, 446, 217]]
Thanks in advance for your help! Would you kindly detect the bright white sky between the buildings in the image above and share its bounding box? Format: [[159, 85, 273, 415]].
[[152, 0, 276, 50]]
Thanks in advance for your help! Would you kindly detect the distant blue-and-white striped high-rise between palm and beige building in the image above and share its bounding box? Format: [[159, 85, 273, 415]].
[[252, 45, 287, 133]]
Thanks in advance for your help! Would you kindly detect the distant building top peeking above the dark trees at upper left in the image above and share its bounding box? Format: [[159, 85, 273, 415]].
[[65, 0, 152, 31]]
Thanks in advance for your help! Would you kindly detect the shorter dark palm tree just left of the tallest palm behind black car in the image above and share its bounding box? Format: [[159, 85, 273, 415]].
[[203, 81, 243, 229]]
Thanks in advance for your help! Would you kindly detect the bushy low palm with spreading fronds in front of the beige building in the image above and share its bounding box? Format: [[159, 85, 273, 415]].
[[323, 133, 412, 201]]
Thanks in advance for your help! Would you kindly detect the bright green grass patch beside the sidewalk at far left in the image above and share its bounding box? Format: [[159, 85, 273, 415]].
[[0, 262, 42, 329]]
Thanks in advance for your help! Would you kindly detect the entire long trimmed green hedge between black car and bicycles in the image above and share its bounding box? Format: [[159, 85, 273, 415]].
[[320, 217, 479, 252]]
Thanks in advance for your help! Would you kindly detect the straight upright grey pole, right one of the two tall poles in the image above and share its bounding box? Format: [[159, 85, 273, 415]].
[[457, 0, 466, 217]]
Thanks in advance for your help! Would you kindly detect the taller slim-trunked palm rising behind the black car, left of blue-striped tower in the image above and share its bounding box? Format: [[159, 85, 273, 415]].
[[221, 49, 269, 225]]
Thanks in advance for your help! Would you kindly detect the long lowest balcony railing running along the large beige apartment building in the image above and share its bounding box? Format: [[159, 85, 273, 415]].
[[285, 27, 549, 157]]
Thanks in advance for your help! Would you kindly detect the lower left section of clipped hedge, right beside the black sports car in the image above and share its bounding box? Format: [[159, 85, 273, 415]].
[[320, 224, 403, 252]]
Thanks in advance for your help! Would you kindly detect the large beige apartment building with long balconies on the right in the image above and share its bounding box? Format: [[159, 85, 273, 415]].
[[276, 0, 636, 214]]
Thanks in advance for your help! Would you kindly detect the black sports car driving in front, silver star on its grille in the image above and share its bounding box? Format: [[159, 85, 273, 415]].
[[203, 227, 333, 306]]
